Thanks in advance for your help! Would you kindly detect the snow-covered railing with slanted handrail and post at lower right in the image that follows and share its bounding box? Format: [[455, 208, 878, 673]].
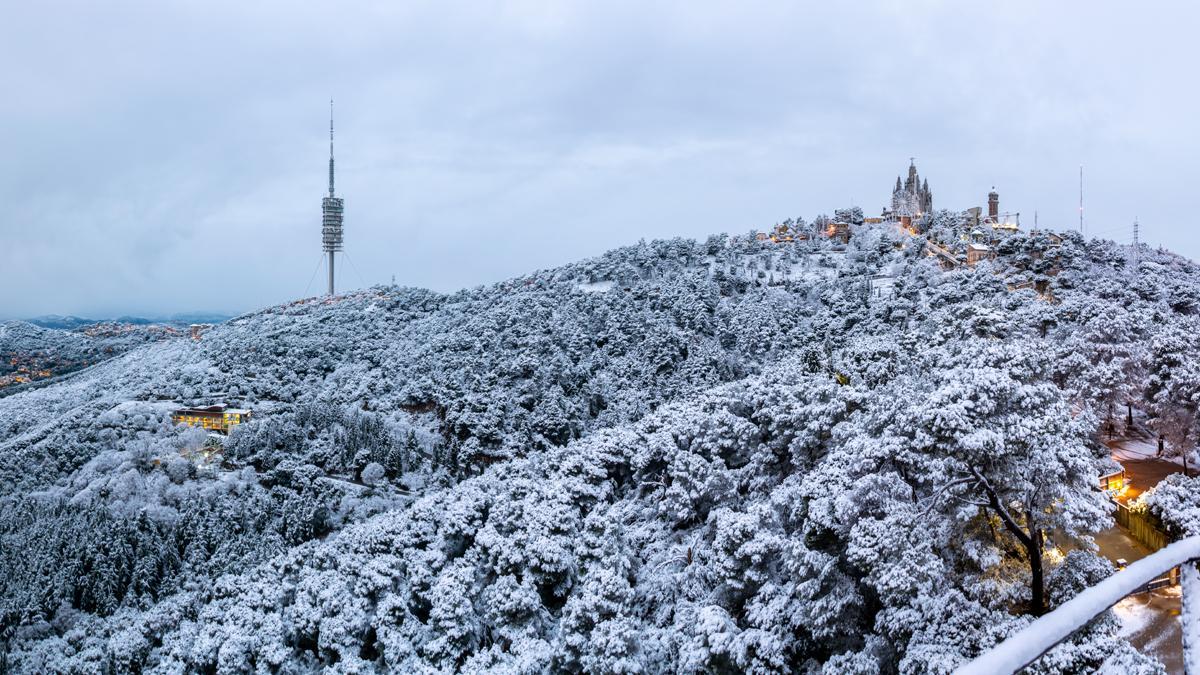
[[955, 536, 1200, 675]]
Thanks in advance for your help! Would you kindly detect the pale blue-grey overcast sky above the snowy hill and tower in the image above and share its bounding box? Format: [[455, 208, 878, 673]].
[[0, 0, 1200, 317]]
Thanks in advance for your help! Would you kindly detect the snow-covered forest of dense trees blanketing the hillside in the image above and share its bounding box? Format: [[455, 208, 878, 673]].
[[0, 218, 1200, 673]]
